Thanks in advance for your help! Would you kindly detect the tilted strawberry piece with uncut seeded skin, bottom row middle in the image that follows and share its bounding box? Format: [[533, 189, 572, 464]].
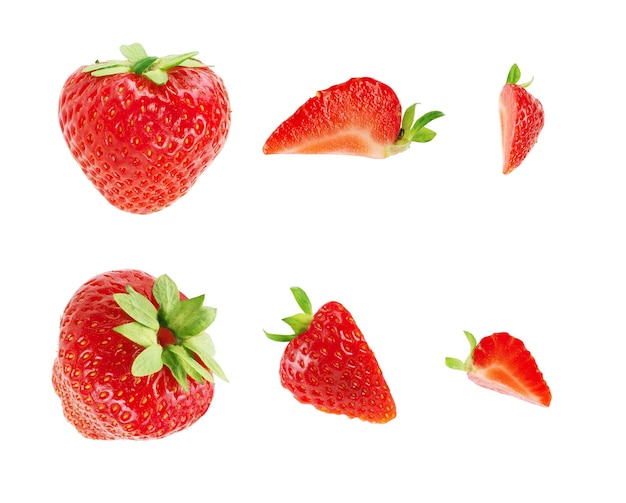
[[265, 287, 396, 423]]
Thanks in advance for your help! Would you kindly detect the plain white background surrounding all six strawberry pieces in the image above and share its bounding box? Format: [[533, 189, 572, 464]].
[[0, 0, 626, 502]]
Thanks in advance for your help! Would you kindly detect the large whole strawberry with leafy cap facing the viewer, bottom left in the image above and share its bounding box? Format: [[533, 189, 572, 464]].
[[52, 270, 226, 439]]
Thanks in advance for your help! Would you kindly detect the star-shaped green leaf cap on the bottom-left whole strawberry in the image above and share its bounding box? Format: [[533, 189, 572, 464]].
[[113, 275, 228, 391]]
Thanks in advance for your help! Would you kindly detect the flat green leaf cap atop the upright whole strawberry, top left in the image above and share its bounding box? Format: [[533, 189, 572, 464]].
[[83, 44, 207, 85]]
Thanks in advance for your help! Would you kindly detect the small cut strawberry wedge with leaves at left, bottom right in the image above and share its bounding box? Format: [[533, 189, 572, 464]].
[[446, 332, 552, 407]]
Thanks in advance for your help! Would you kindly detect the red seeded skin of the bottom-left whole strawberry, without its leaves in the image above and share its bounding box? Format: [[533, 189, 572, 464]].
[[52, 270, 227, 440]]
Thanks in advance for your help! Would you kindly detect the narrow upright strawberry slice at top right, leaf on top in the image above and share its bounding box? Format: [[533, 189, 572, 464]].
[[500, 65, 544, 175]]
